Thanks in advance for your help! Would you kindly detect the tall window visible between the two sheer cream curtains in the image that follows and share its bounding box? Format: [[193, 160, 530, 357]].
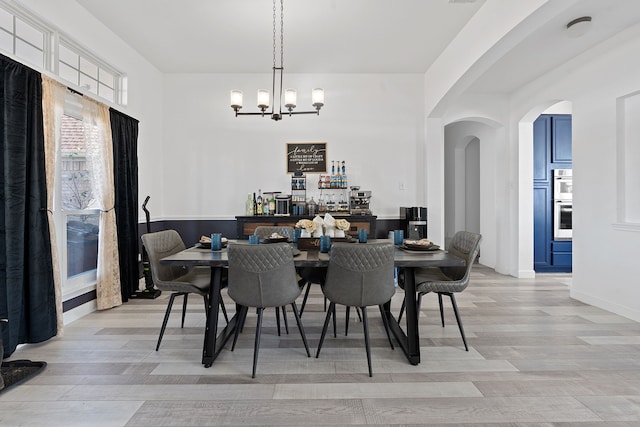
[[54, 109, 100, 294]]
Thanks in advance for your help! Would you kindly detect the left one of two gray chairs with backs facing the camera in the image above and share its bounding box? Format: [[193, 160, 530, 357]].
[[227, 243, 311, 378]]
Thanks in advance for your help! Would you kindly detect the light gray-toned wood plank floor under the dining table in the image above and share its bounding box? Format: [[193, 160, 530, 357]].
[[0, 267, 640, 427]]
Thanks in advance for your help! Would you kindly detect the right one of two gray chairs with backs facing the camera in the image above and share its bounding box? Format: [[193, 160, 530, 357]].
[[316, 243, 395, 376]]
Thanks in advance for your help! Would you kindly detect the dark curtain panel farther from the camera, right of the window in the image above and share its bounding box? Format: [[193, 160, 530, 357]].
[[109, 108, 139, 301]]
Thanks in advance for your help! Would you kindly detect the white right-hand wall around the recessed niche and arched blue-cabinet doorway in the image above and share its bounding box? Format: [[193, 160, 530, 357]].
[[512, 22, 640, 320]]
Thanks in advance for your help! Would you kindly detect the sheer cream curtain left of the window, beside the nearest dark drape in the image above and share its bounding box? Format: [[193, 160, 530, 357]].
[[42, 75, 67, 335]]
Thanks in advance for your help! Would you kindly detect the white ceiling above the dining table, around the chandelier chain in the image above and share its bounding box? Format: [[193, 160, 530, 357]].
[[77, 0, 484, 73]]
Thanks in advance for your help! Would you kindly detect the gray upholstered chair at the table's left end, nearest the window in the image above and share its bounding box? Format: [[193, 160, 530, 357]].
[[142, 230, 229, 351]]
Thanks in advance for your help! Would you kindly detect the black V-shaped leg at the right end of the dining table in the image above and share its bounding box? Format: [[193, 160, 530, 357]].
[[384, 267, 420, 365]]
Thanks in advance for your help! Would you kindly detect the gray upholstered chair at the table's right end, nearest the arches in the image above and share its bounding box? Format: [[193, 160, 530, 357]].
[[398, 231, 482, 351]]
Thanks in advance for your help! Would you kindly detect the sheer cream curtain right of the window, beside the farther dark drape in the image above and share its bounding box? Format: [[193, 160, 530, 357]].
[[82, 96, 122, 310]]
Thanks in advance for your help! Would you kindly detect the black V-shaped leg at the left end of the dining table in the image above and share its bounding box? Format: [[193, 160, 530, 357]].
[[202, 267, 238, 368]]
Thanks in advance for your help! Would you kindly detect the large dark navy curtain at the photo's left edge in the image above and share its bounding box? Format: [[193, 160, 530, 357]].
[[0, 55, 57, 357]]
